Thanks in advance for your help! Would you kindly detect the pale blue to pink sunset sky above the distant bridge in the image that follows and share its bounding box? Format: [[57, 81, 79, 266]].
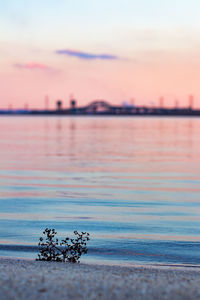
[[0, 0, 200, 108]]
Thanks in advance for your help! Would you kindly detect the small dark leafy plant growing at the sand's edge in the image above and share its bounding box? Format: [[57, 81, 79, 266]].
[[36, 228, 90, 263]]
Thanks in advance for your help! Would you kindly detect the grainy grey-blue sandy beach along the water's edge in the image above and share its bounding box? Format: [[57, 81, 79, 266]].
[[0, 258, 200, 300]]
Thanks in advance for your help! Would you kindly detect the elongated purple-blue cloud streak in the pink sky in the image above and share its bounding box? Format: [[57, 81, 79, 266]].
[[56, 49, 119, 60]]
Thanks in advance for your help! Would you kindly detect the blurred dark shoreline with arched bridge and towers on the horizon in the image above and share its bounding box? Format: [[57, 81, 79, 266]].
[[0, 95, 200, 116]]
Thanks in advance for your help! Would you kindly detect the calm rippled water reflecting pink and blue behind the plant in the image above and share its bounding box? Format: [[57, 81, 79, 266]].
[[0, 117, 200, 264]]
